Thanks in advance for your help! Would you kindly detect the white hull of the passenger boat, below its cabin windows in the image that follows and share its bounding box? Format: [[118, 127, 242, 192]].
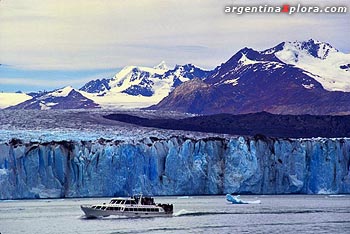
[[80, 205, 173, 218]]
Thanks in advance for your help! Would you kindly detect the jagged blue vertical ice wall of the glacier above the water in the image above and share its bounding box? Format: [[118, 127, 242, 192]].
[[0, 136, 350, 199]]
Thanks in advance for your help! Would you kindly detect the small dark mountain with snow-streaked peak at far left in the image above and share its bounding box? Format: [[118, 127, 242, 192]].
[[7, 86, 99, 110]]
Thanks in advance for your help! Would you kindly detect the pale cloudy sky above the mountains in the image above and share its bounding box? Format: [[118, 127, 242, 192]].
[[0, 0, 350, 92]]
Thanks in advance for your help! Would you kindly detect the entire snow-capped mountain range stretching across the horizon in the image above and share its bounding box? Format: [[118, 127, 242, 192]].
[[4, 39, 350, 114]]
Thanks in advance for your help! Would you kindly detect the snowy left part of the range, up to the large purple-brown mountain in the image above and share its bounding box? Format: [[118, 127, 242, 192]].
[[4, 61, 209, 109]]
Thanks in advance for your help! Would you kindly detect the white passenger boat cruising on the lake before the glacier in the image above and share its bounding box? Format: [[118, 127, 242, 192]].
[[80, 195, 173, 218]]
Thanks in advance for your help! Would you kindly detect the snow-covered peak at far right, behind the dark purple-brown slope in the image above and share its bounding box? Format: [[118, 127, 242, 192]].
[[262, 39, 350, 92]]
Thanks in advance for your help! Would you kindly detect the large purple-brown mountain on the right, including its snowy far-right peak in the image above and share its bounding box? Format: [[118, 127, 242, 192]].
[[150, 40, 350, 115]]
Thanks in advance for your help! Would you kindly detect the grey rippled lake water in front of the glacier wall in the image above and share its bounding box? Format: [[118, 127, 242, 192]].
[[0, 195, 350, 234]]
